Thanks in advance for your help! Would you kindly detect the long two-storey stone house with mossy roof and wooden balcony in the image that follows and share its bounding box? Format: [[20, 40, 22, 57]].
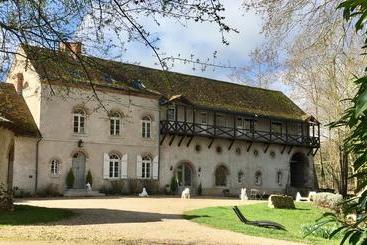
[[7, 43, 320, 194]]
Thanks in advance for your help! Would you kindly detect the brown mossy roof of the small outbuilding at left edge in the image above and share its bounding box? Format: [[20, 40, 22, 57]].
[[0, 82, 40, 137]]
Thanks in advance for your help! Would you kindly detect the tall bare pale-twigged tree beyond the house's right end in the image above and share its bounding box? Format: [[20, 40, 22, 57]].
[[244, 0, 366, 195]]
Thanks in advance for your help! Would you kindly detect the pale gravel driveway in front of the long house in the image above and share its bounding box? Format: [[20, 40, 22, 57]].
[[0, 197, 302, 245]]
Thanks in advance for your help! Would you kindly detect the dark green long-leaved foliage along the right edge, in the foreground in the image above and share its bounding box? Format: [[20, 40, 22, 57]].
[[310, 0, 367, 244]]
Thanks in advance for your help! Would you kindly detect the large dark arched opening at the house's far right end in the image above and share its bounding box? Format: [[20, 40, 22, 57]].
[[290, 152, 309, 188]]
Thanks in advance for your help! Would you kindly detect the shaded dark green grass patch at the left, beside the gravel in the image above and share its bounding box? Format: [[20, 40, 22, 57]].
[[0, 205, 74, 226]]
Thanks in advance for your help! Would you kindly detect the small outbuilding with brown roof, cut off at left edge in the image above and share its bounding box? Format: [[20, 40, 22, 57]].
[[0, 83, 40, 189]]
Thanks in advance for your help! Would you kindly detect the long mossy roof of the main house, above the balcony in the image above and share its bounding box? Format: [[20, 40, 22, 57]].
[[23, 46, 307, 120]]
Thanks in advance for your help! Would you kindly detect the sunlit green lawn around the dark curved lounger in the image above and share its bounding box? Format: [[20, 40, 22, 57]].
[[184, 203, 338, 244]]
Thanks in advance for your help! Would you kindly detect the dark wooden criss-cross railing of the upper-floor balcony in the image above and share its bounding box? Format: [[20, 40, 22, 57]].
[[160, 120, 320, 148]]
